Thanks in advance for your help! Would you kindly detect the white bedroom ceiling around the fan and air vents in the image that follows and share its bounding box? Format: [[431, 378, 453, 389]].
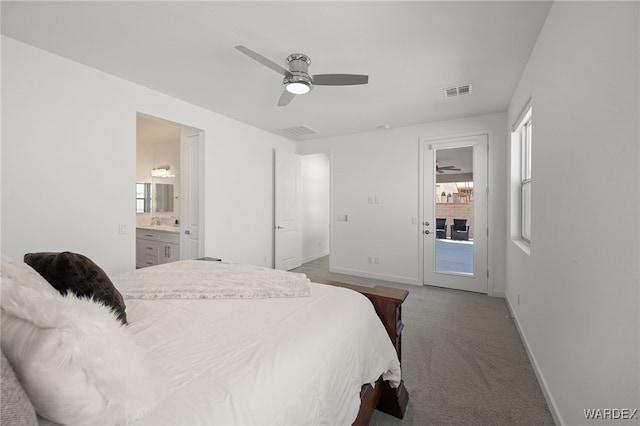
[[1, 1, 550, 140]]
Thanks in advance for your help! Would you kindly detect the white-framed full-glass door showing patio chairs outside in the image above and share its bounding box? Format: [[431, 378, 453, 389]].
[[422, 134, 489, 293]]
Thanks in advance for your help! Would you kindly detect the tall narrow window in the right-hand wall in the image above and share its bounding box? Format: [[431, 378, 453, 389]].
[[516, 108, 532, 242]]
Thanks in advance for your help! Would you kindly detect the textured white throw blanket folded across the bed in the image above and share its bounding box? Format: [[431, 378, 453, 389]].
[[112, 260, 311, 299]]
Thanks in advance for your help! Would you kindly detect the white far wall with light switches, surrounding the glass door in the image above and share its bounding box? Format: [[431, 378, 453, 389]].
[[297, 113, 507, 295]]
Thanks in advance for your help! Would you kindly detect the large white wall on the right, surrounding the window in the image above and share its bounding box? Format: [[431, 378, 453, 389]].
[[506, 2, 640, 425]]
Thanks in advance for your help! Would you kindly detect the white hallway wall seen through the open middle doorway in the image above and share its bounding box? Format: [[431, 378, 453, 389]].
[[300, 153, 331, 263]]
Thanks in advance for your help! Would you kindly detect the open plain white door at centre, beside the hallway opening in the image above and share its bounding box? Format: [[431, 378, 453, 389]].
[[274, 150, 302, 271]]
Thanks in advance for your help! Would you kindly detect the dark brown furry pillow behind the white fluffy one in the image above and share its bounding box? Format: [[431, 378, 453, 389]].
[[24, 251, 127, 324]]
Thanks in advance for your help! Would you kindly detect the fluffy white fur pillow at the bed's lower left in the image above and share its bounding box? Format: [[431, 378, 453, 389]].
[[0, 263, 154, 425]]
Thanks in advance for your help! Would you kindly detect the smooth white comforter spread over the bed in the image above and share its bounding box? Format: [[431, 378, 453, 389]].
[[113, 262, 400, 425]]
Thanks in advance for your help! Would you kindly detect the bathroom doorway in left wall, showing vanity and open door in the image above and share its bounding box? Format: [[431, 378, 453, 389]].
[[136, 113, 204, 267]]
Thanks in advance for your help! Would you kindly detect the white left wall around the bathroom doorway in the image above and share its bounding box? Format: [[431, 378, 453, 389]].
[[1, 37, 295, 274]]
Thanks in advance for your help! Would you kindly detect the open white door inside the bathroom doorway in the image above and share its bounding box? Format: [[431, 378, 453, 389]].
[[180, 129, 204, 260]]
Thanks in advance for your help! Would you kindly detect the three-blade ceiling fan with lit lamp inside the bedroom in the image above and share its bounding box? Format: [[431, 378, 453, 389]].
[[235, 46, 369, 106]]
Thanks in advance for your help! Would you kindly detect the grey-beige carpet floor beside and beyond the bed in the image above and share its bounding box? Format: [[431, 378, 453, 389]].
[[293, 256, 554, 426]]
